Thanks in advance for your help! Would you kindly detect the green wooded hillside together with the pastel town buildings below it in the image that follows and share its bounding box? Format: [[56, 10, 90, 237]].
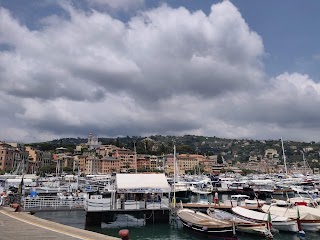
[[0, 133, 320, 175]]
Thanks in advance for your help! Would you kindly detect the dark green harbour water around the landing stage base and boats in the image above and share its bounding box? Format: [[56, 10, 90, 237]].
[[36, 211, 320, 240]]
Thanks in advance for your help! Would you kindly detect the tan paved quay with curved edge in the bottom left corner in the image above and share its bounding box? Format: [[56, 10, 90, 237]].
[[0, 207, 120, 240]]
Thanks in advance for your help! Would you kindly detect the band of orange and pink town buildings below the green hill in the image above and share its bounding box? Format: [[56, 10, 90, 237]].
[[0, 134, 312, 175]]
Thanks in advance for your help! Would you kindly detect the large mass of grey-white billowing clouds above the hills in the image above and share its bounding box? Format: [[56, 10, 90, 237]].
[[0, 1, 319, 141]]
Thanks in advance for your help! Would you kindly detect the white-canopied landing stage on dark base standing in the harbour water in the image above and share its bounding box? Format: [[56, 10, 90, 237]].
[[85, 174, 171, 226]]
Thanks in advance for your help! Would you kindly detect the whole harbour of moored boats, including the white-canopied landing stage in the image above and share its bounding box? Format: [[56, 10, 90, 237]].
[[0, 139, 320, 239]]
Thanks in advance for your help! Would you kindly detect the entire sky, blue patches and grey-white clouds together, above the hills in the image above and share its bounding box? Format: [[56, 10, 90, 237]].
[[0, 0, 320, 143]]
